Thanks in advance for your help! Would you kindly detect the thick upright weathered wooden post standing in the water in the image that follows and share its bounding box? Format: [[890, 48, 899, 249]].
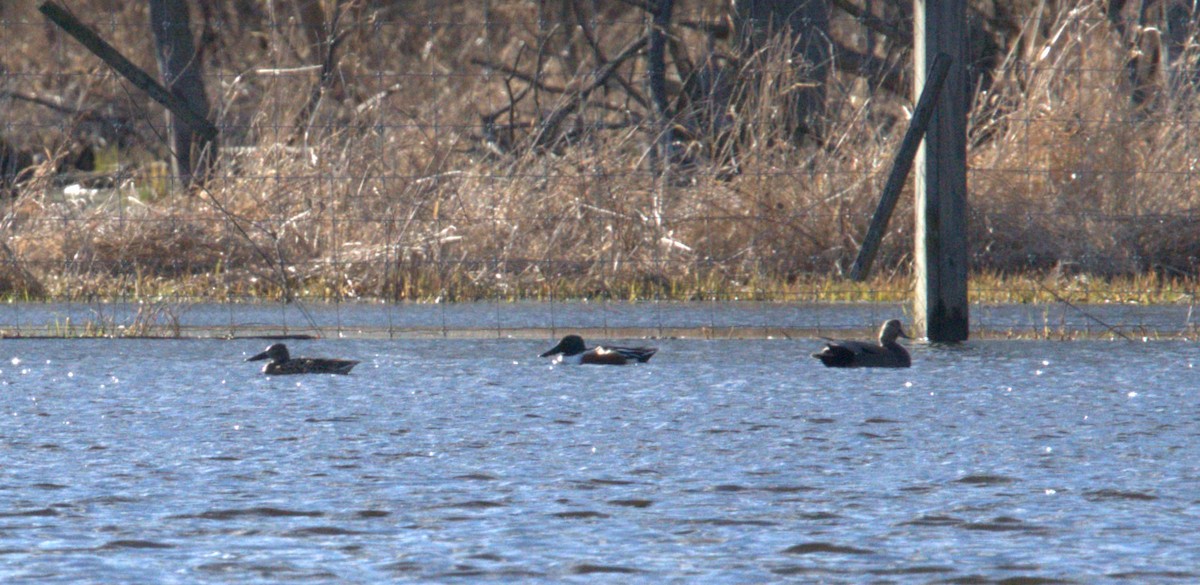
[[913, 0, 968, 342]]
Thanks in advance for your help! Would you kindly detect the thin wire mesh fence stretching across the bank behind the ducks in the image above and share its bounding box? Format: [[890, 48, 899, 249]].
[[0, 0, 1200, 336]]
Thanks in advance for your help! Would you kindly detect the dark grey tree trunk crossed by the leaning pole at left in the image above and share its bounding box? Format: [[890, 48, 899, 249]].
[[150, 0, 215, 185]]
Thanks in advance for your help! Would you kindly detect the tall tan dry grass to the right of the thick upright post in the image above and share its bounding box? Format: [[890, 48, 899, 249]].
[[971, 2, 1200, 277]]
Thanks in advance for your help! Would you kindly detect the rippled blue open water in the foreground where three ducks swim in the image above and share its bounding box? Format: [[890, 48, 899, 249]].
[[0, 330, 1200, 584]]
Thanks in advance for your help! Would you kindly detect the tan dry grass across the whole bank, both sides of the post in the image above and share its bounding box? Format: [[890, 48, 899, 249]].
[[0, 0, 1200, 302]]
